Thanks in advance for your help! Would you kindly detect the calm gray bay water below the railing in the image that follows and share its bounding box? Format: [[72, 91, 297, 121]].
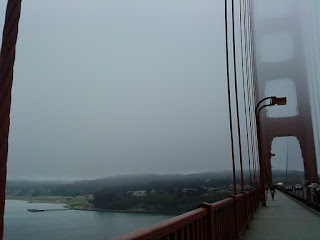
[[4, 200, 173, 240]]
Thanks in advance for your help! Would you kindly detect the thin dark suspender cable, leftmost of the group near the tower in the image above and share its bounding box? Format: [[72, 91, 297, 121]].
[[224, 0, 237, 195]]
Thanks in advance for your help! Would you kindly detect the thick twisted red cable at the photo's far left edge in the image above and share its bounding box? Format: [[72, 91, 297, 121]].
[[0, 0, 21, 239]]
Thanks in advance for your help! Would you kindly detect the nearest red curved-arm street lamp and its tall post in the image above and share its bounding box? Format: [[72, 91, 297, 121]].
[[255, 96, 287, 206]]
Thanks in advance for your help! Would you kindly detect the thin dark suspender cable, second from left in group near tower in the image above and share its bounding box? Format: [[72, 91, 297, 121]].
[[232, 0, 244, 191]]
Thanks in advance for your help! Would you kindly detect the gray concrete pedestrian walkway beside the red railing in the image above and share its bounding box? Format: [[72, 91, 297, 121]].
[[243, 190, 320, 240]]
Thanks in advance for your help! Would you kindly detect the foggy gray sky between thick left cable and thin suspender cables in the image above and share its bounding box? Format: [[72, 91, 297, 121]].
[[1, 0, 235, 179]]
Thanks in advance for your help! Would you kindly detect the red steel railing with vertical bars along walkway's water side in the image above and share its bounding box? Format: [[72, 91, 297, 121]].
[[113, 190, 260, 240]]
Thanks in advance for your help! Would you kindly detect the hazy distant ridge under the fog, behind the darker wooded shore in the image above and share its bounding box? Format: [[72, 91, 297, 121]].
[[6, 170, 303, 196]]
